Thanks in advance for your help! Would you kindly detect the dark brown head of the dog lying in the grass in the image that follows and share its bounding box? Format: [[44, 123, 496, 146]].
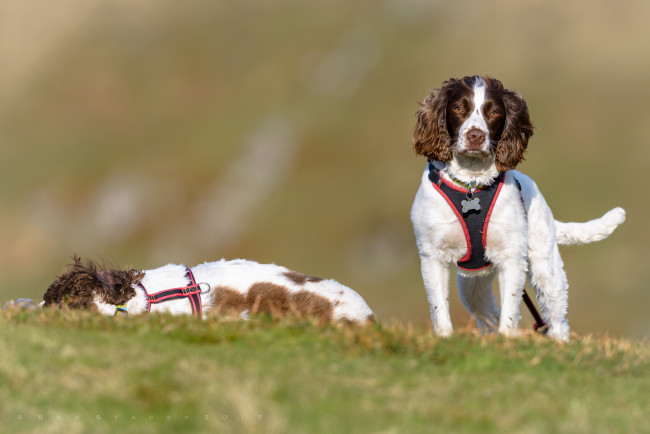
[[43, 255, 143, 309]]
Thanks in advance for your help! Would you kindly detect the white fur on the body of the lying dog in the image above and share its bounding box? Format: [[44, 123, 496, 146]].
[[95, 259, 373, 322]]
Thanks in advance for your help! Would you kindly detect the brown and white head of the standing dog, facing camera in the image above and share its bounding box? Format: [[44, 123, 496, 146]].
[[413, 76, 533, 172]]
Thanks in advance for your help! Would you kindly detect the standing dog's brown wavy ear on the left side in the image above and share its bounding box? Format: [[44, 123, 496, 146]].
[[413, 79, 454, 161]]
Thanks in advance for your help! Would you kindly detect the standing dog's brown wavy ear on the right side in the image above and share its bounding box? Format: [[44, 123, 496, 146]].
[[496, 90, 534, 172]]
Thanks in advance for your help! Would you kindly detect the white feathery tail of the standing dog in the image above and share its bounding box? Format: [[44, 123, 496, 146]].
[[555, 208, 625, 246]]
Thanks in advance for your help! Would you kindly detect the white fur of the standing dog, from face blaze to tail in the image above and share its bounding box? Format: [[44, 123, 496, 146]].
[[411, 81, 625, 341]]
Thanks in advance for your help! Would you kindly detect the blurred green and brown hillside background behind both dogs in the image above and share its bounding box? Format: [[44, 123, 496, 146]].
[[0, 0, 650, 337]]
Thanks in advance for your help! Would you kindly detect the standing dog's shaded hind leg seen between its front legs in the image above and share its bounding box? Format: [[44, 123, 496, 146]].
[[456, 272, 499, 334]]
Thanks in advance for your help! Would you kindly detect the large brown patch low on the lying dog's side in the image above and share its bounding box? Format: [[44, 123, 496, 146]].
[[212, 282, 334, 322]]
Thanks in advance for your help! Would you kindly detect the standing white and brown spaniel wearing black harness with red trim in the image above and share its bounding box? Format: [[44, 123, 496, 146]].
[[411, 76, 625, 341]]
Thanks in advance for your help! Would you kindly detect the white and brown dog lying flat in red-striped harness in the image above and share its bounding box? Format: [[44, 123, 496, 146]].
[[43, 255, 374, 323]]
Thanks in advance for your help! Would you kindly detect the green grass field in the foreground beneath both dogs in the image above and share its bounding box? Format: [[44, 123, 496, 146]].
[[0, 311, 650, 433]]
